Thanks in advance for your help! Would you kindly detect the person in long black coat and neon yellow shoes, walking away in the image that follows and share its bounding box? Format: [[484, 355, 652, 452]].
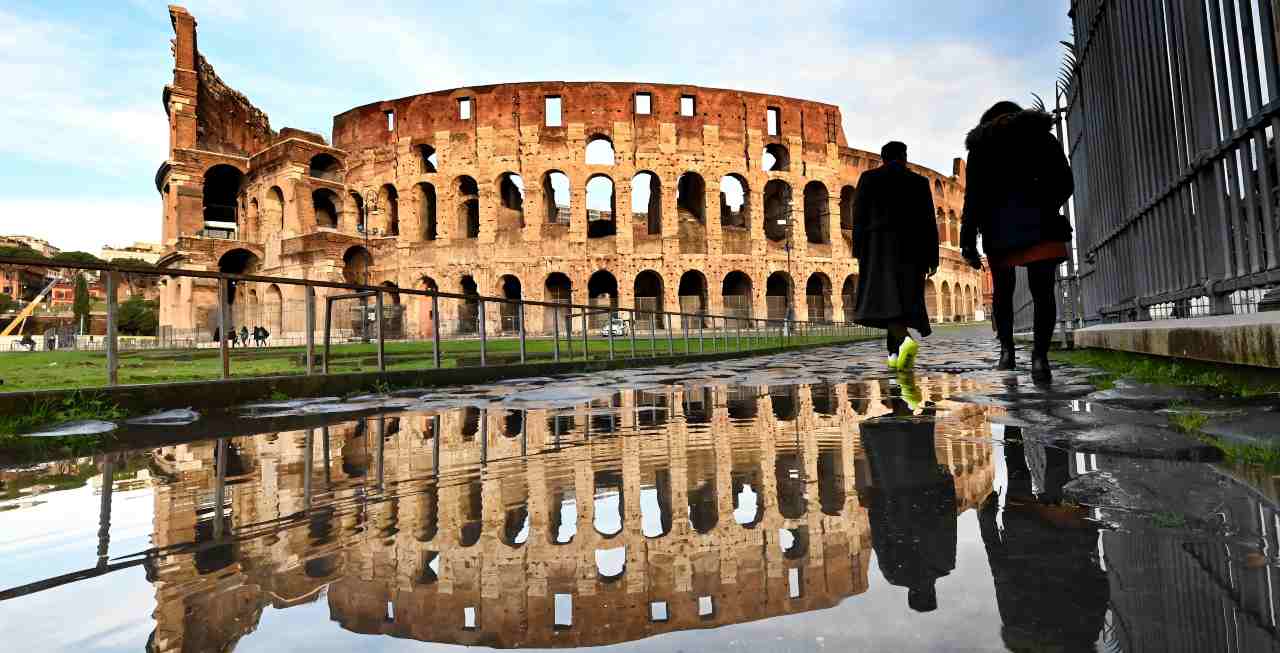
[[854, 141, 938, 370]]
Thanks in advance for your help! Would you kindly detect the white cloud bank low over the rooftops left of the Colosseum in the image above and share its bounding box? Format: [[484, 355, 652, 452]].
[[0, 191, 163, 255]]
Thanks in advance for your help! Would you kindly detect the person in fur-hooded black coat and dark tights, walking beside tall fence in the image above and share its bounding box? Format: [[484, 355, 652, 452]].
[[960, 101, 1074, 382]]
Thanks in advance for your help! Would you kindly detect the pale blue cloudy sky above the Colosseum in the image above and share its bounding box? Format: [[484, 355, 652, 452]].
[[0, 0, 1070, 252]]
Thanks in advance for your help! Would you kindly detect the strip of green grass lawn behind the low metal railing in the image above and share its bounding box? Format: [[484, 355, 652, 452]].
[[0, 330, 878, 392]]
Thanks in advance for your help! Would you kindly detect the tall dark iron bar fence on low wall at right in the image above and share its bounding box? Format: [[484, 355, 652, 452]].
[[1059, 0, 1280, 321]]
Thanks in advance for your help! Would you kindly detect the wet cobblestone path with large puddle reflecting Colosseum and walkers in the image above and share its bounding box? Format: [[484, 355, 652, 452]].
[[0, 329, 1280, 652]]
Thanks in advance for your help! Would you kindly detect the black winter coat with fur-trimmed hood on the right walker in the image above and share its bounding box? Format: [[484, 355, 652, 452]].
[[960, 109, 1074, 255]]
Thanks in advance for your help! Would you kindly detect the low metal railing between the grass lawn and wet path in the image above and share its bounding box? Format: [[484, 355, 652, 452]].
[[0, 256, 879, 385]]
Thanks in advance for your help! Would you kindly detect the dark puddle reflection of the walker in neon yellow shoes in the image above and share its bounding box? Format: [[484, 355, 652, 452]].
[[859, 398, 956, 612]]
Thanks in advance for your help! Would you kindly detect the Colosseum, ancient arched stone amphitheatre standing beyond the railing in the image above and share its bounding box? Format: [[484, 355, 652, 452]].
[[155, 6, 982, 337]]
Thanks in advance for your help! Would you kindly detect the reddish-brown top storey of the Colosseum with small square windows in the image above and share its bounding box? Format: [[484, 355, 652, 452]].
[[333, 82, 846, 151]]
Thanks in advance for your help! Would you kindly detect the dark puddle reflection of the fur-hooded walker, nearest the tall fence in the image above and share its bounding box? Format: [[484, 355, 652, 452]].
[[978, 426, 1110, 650]]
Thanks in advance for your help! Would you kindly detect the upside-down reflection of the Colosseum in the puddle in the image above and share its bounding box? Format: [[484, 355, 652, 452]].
[[148, 380, 992, 650]]
